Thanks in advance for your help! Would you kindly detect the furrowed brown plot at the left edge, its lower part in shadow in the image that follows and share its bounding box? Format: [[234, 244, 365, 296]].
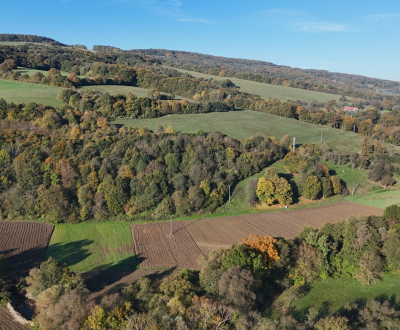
[[0, 221, 54, 276]]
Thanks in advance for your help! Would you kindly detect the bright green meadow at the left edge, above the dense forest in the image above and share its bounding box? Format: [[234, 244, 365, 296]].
[[0, 80, 62, 107]]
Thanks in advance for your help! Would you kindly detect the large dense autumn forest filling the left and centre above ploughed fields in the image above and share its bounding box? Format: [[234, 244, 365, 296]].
[[0, 99, 286, 223]]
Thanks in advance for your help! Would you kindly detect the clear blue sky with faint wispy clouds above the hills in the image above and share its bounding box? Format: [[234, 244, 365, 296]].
[[0, 0, 400, 81]]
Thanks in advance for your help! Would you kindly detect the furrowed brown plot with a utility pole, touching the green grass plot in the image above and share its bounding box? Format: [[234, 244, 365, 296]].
[[131, 222, 202, 269]]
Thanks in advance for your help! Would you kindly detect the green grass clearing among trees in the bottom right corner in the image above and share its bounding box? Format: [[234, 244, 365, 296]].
[[290, 274, 400, 320]]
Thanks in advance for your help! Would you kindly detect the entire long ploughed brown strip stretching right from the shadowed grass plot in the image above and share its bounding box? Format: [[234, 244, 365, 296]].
[[131, 202, 383, 269]]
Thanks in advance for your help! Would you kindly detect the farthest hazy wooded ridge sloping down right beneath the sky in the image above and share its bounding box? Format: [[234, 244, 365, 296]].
[[131, 49, 400, 95]]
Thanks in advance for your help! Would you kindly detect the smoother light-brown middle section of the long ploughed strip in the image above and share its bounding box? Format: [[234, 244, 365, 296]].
[[185, 217, 263, 255]]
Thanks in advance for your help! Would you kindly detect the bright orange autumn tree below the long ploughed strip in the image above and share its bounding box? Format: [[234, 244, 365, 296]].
[[243, 234, 280, 268]]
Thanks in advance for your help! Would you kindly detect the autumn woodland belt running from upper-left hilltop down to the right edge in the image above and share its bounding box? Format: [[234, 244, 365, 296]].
[[0, 39, 400, 144]]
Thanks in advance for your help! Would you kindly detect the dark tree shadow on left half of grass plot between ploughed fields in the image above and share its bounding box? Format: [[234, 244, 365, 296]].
[[48, 239, 94, 267]]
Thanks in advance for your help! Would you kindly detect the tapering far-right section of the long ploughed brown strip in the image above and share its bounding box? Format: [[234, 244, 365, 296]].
[[239, 202, 383, 238]]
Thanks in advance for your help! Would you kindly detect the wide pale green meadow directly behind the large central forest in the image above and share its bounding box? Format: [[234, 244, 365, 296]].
[[112, 110, 362, 152]]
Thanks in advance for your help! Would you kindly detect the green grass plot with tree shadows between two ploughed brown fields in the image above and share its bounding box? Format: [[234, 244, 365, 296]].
[[46, 222, 137, 272]]
